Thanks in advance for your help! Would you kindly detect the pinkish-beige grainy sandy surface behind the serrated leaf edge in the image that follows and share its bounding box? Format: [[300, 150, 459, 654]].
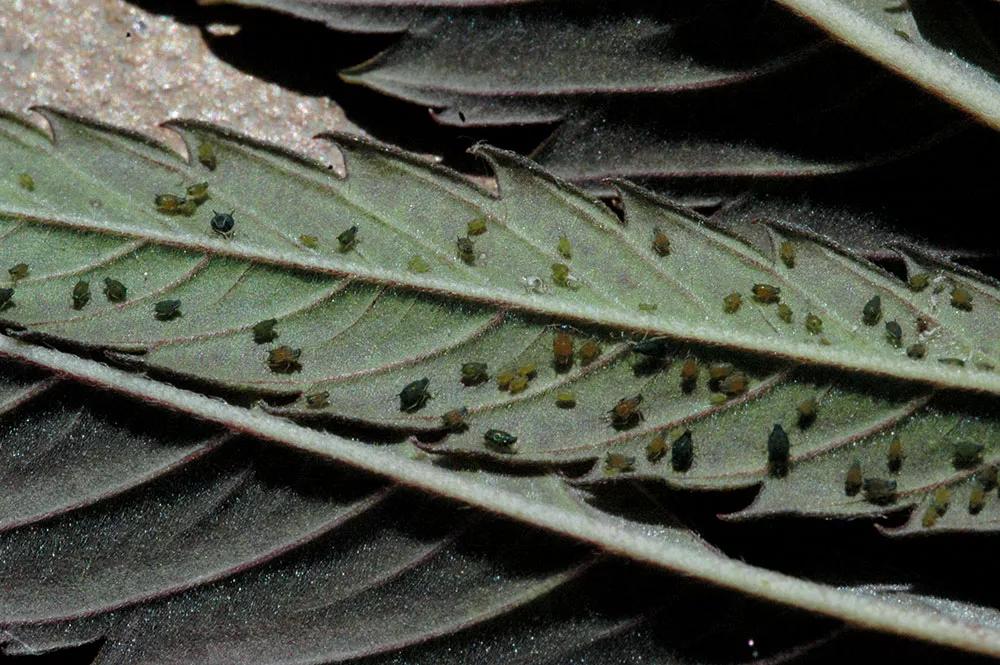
[[0, 0, 355, 162]]
